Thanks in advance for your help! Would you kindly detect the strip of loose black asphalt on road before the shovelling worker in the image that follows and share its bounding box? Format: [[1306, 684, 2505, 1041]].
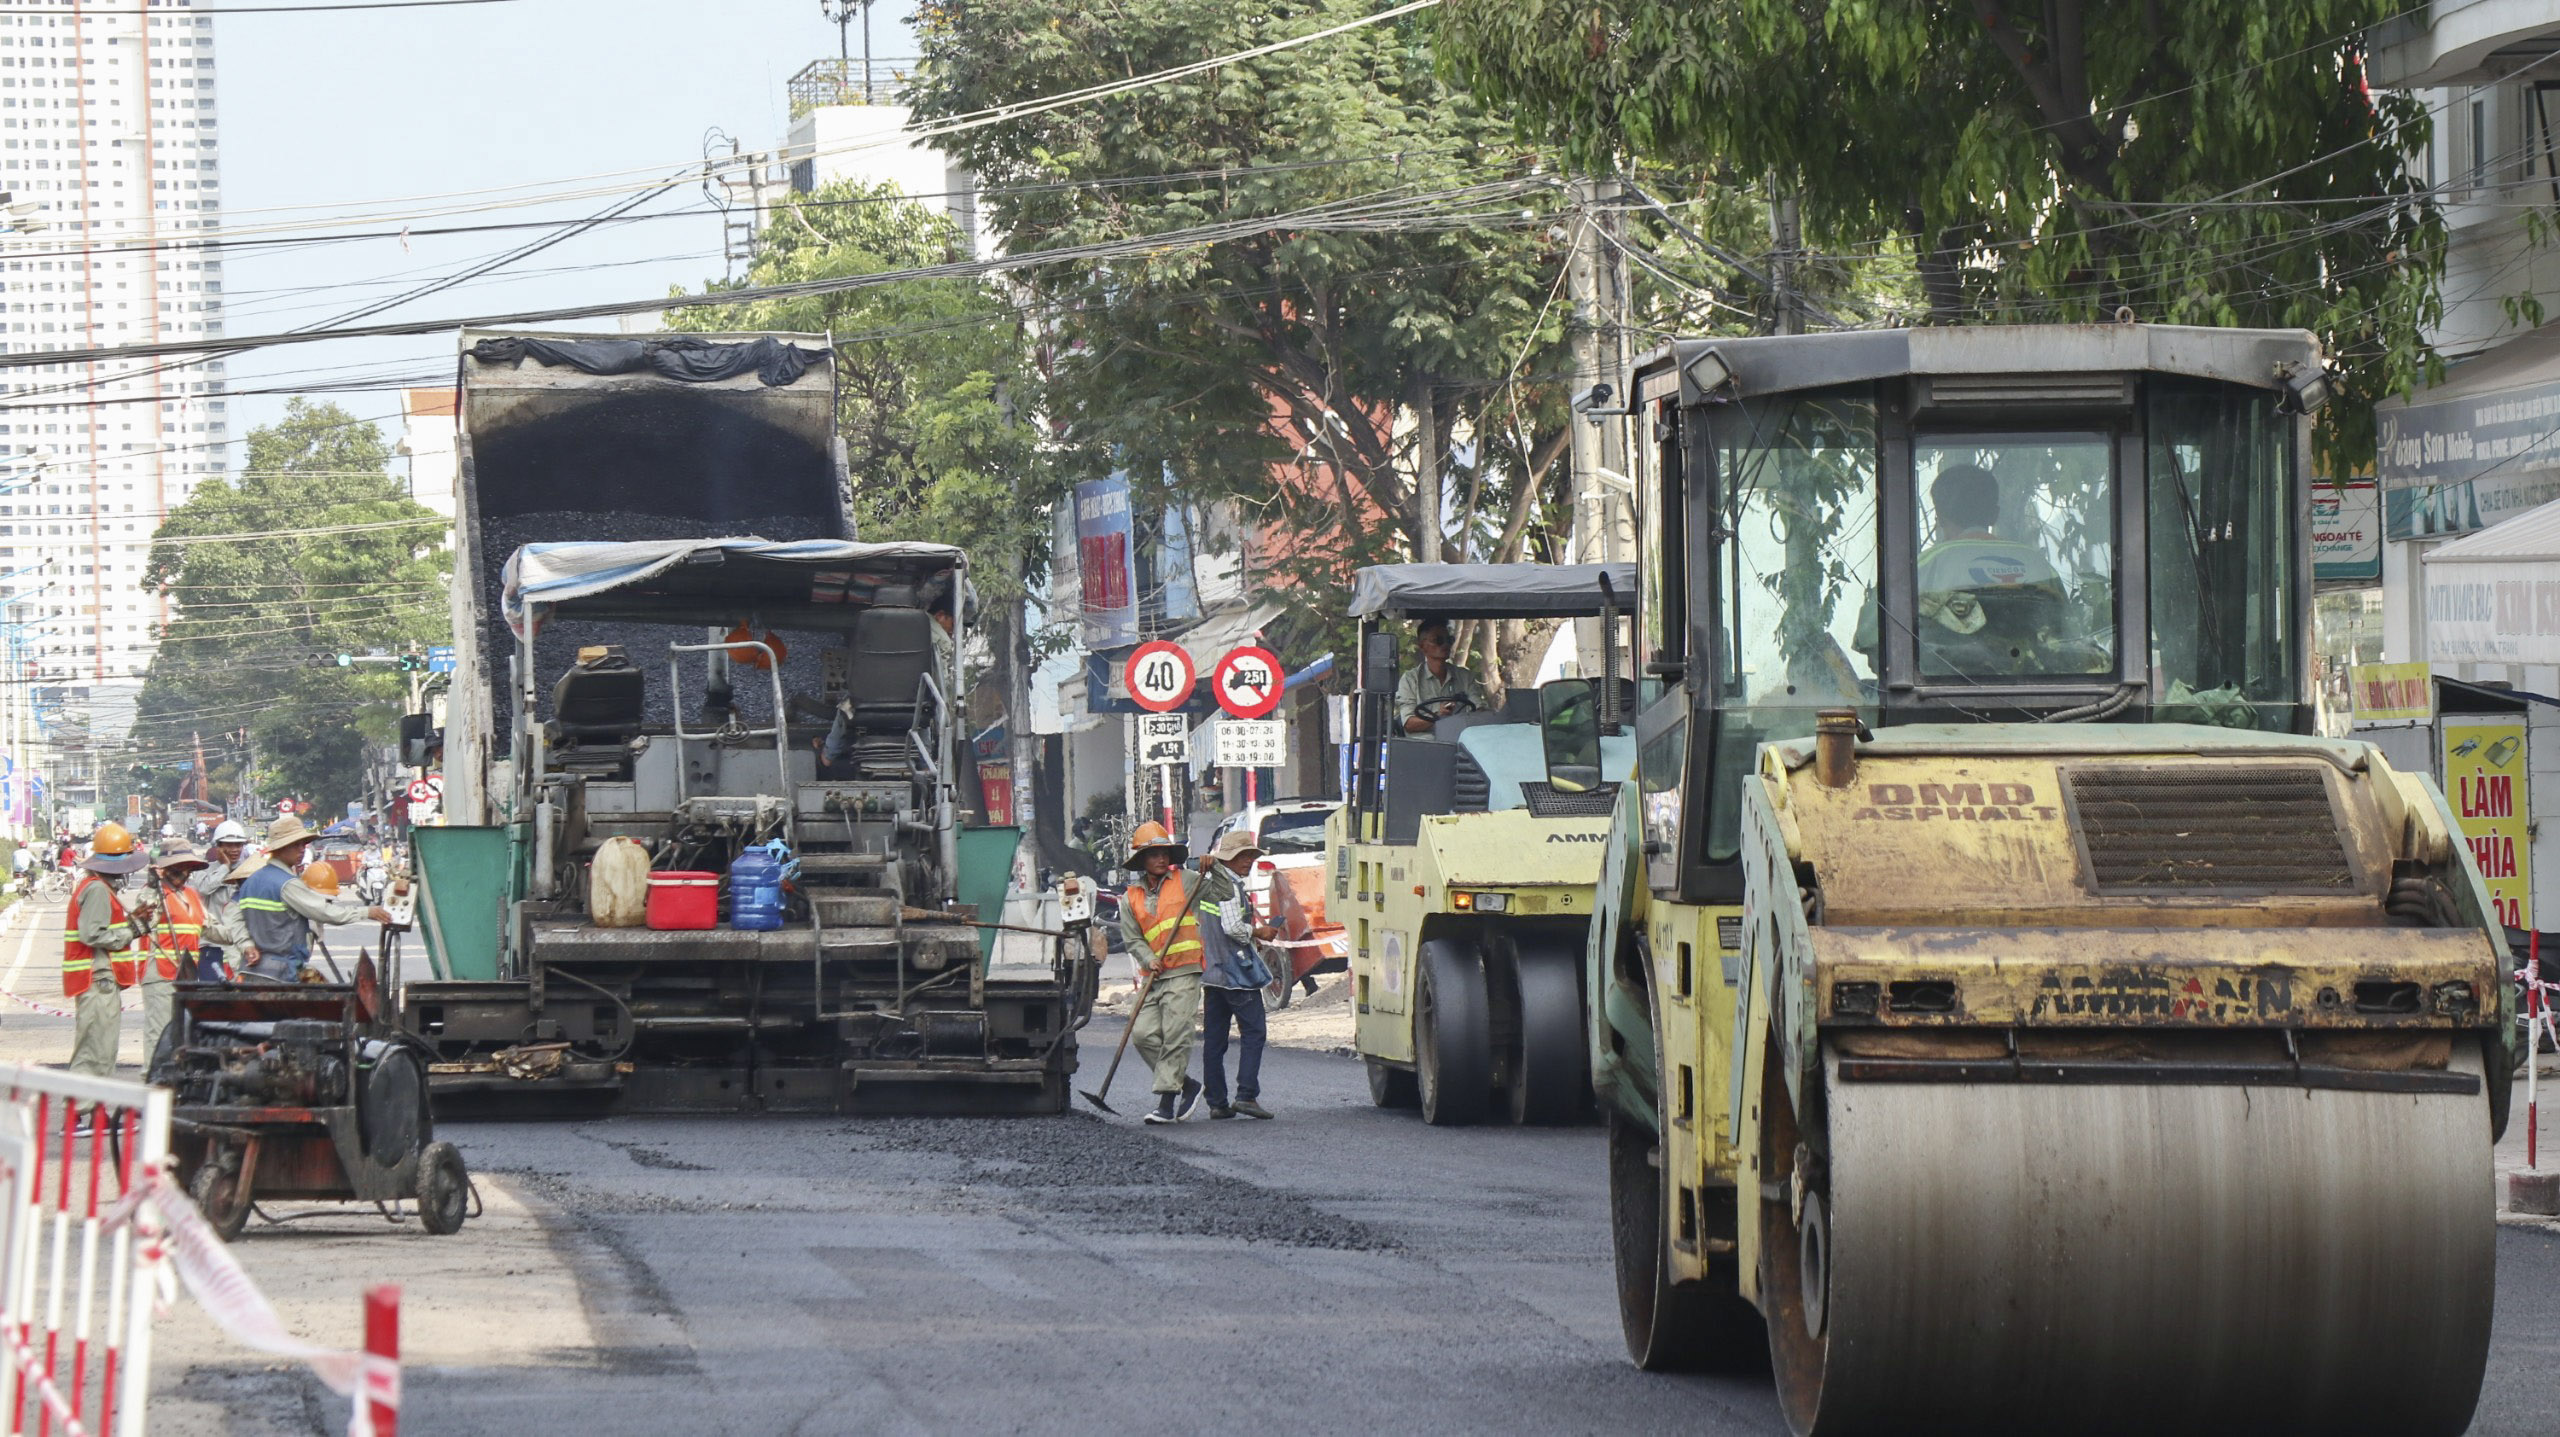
[[850, 1111, 1395, 1253]]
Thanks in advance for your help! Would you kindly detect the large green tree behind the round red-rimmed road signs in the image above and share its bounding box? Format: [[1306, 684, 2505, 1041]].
[[909, 0, 1569, 607]]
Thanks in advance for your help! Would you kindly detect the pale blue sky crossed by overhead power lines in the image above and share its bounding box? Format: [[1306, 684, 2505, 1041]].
[[205, 0, 914, 453]]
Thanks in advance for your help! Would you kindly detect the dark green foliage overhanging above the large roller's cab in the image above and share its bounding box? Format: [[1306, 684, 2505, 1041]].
[[1439, 0, 2445, 466]]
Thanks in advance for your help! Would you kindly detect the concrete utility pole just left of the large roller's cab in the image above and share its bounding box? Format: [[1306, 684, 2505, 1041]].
[[1564, 179, 1636, 676]]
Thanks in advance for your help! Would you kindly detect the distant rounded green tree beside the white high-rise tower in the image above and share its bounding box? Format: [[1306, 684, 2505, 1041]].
[[133, 397, 453, 809]]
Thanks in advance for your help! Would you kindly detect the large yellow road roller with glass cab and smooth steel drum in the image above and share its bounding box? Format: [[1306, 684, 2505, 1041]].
[[1587, 323, 2516, 1437]]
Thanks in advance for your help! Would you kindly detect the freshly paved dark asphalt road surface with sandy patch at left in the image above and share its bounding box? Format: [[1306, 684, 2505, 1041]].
[[0, 896, 2560, 1437]]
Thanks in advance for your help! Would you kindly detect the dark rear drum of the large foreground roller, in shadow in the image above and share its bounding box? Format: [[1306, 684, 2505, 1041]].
[[1608, 1109, 1769, 1373]]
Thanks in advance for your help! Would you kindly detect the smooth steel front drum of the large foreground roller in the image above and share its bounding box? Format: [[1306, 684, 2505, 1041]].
[[1772, 1039, 2496, 1437]]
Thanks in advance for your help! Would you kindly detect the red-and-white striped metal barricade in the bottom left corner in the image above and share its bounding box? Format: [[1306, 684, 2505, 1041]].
[[0, 1063, 169, 1437]]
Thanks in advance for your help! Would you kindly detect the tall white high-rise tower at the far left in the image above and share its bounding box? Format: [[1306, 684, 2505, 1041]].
[[0, 0, 228, 740]]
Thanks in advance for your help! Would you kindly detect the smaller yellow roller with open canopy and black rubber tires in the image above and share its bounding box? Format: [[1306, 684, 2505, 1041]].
[[1326, 564, 1636, 1124]]
